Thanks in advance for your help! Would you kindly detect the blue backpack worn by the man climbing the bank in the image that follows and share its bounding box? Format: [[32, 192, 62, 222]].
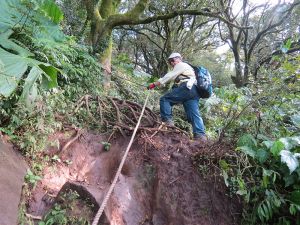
[[190, 65, 213, 98]]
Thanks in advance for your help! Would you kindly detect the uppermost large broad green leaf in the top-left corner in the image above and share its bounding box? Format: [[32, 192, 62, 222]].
[[0, 0, 65, 42]]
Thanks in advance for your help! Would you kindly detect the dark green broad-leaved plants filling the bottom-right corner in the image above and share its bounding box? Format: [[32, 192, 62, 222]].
[[230, 134, 300, 224]]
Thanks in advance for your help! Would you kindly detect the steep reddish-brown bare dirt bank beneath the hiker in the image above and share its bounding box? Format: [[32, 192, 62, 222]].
[[28, 129, 240, 225]]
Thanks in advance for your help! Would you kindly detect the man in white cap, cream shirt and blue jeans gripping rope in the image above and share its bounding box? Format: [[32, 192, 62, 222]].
[[148, 53, 207, 141]]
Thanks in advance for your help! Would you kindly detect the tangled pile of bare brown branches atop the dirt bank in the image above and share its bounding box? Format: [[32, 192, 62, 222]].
[[72, 95, 188, 137]]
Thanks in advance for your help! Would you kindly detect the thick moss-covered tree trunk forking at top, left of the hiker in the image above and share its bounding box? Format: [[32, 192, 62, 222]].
[[84, 0, 149, 89]]
